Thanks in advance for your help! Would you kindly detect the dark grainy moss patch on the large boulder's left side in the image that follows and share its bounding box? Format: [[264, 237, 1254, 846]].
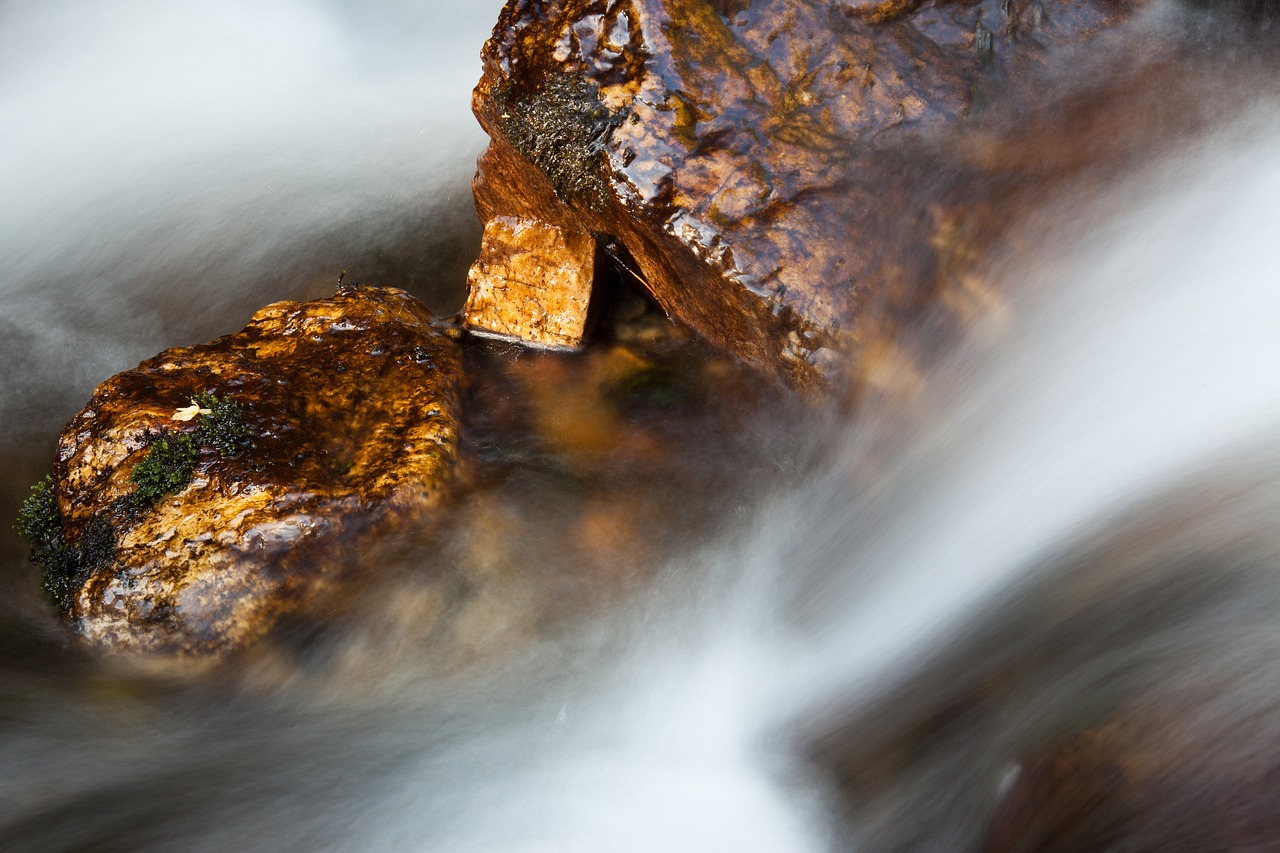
[[494, 72, 622, 210]]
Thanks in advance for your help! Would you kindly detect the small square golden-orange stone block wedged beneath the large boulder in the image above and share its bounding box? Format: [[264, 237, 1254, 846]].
[[462, 216, 595, 350]]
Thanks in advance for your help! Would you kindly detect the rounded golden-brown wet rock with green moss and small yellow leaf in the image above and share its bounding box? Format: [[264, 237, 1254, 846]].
[[28, 287, 461, 654]]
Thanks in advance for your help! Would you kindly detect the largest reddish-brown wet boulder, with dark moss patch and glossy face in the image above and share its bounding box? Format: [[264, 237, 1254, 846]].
[[474, 0, 1140, 389]]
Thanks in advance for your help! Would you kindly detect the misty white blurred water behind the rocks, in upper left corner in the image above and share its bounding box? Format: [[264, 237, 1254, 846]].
[[0, 0, 500, 450]]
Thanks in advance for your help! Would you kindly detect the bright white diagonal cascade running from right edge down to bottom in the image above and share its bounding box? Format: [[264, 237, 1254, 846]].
[[427, 104, 1280, 850]]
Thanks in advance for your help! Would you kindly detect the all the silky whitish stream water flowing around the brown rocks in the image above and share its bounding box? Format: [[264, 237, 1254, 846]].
[[0, 0, 1280, 850]]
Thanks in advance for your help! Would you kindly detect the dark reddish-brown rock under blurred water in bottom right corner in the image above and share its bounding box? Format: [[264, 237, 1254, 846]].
[[978, 708, 1280, 853]]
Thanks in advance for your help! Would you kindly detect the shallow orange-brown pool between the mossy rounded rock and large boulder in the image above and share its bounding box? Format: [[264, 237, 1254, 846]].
[[230, 292, 820, 703]]
